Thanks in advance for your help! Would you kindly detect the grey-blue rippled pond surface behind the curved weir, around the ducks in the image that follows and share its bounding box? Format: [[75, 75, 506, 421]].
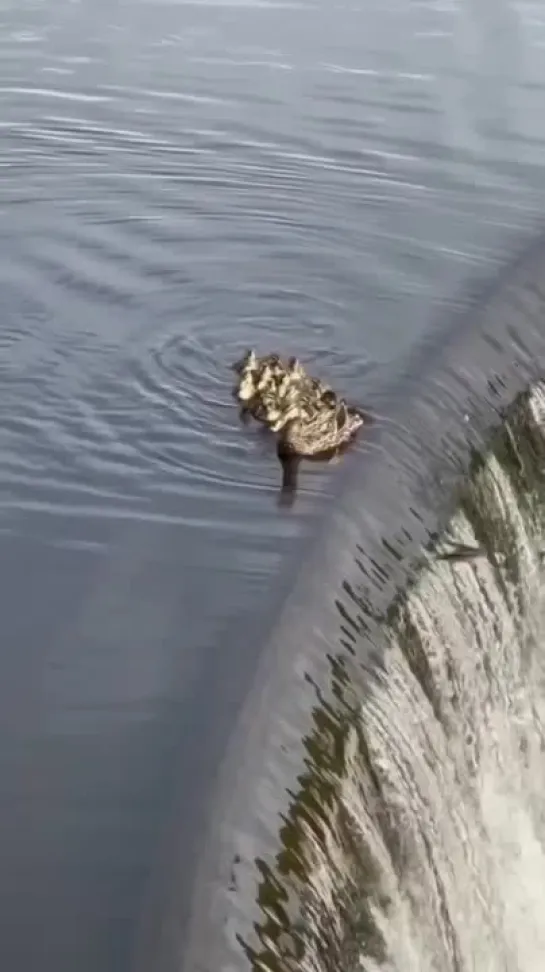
[[0, 0, 545, 972]]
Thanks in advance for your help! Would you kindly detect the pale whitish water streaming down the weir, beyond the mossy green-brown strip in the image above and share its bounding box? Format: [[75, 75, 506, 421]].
[[362, 394, 545, 972]]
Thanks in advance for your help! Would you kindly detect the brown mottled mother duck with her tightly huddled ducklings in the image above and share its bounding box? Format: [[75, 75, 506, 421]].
[[233, 350, 365, 458]]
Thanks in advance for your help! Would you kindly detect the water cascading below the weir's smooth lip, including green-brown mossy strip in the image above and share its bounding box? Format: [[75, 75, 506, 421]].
[[234, 385, 545, 972]]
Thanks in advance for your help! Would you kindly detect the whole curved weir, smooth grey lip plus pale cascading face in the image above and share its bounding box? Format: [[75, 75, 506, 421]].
[[135, 239, 545, 972]]
